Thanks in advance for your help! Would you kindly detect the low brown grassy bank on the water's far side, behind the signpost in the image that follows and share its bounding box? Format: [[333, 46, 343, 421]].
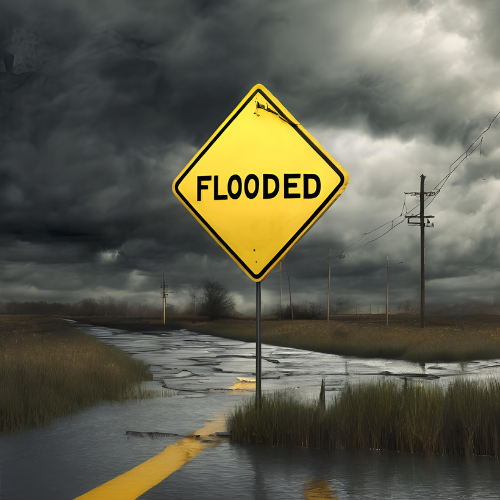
[[82, 314, 500, 362]]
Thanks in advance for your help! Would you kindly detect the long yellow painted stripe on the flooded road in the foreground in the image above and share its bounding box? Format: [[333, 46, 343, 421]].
[[75, 418, 224, 500]]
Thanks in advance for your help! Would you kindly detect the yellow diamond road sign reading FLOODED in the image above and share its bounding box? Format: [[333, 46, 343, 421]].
[[173, 85, 349, 282]]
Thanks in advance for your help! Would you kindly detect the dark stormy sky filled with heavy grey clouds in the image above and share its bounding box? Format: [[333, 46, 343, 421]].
[[0, 0, 500, 312]]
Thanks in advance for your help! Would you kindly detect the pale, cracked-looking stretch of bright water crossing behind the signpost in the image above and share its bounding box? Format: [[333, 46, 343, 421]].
[[81, 326, 500, 396]]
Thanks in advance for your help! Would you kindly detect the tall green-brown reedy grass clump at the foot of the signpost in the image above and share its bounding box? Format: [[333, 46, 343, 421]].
[[227, 380, 500, 456]]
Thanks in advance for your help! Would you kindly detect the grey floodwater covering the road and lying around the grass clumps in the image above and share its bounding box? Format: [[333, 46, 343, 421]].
[[0, 325, 500, 500]]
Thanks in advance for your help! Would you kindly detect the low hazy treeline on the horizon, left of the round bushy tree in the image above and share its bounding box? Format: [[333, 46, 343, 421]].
[[2, 298, 177, 317]]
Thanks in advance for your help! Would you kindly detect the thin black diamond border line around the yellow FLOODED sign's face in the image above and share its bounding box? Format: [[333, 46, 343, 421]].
[[174, 89, 345, 281]]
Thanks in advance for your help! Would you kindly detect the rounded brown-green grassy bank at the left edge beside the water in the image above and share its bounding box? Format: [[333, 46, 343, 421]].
[[0, 314, 152, 433]]
